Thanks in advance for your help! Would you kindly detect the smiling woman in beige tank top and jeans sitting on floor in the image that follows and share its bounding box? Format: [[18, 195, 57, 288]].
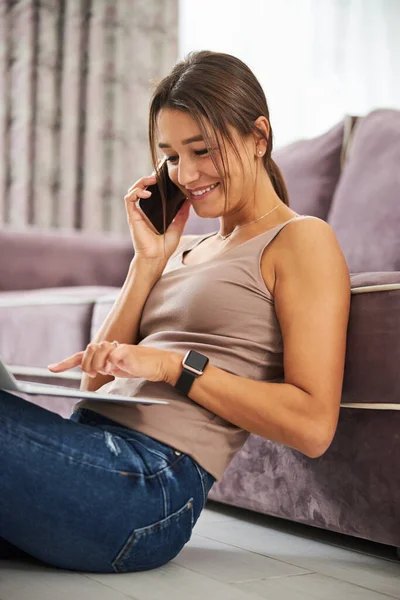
[[0, 51, 350, 572]]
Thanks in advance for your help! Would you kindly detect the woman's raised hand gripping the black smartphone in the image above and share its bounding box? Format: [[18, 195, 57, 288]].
[[125, 175, 190, 264]]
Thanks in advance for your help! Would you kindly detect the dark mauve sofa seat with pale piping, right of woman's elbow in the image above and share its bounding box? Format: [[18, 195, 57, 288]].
[[342, 271, 400, 409]]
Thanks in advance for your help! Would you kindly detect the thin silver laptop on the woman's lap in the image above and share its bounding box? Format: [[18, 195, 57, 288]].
[[0, 360, 168, 404]]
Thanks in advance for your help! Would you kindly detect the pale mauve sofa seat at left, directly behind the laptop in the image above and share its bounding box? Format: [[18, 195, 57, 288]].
[[0, 286, 119, 417]]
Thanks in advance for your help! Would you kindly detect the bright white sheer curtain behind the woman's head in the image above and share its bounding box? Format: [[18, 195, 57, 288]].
[[179, 0, 400, 148]]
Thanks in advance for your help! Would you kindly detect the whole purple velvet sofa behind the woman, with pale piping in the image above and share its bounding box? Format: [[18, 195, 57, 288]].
[[0, 109, 400, 547]]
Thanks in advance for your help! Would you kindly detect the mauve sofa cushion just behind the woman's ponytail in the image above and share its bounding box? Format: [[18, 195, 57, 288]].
[[272, 121, 344, 220]]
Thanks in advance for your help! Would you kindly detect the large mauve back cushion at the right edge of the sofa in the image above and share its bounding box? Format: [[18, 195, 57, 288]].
[[328, 109, 400, 273]]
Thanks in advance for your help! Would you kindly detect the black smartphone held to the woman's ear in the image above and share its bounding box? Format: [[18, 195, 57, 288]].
[[136, 157, 186, 235]]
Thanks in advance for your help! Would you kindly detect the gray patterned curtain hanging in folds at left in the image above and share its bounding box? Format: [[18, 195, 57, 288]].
[[0, 0, 178, 232]]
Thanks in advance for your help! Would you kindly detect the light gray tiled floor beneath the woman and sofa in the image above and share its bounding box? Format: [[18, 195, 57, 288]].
[[0, 502, 400, 600]]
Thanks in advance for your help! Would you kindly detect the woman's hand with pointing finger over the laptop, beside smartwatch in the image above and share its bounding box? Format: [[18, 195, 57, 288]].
[[48, 342, 176, 381]]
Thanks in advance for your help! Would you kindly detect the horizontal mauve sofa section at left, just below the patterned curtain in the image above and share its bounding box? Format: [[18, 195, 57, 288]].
[[0, 227, 134, 290]]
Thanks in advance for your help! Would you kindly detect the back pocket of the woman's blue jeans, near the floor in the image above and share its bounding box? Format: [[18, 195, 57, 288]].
[[112, 498, 194, 573]]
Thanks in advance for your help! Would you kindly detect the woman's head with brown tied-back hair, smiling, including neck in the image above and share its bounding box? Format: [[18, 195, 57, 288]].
[[149, 51, 289, 237]]
